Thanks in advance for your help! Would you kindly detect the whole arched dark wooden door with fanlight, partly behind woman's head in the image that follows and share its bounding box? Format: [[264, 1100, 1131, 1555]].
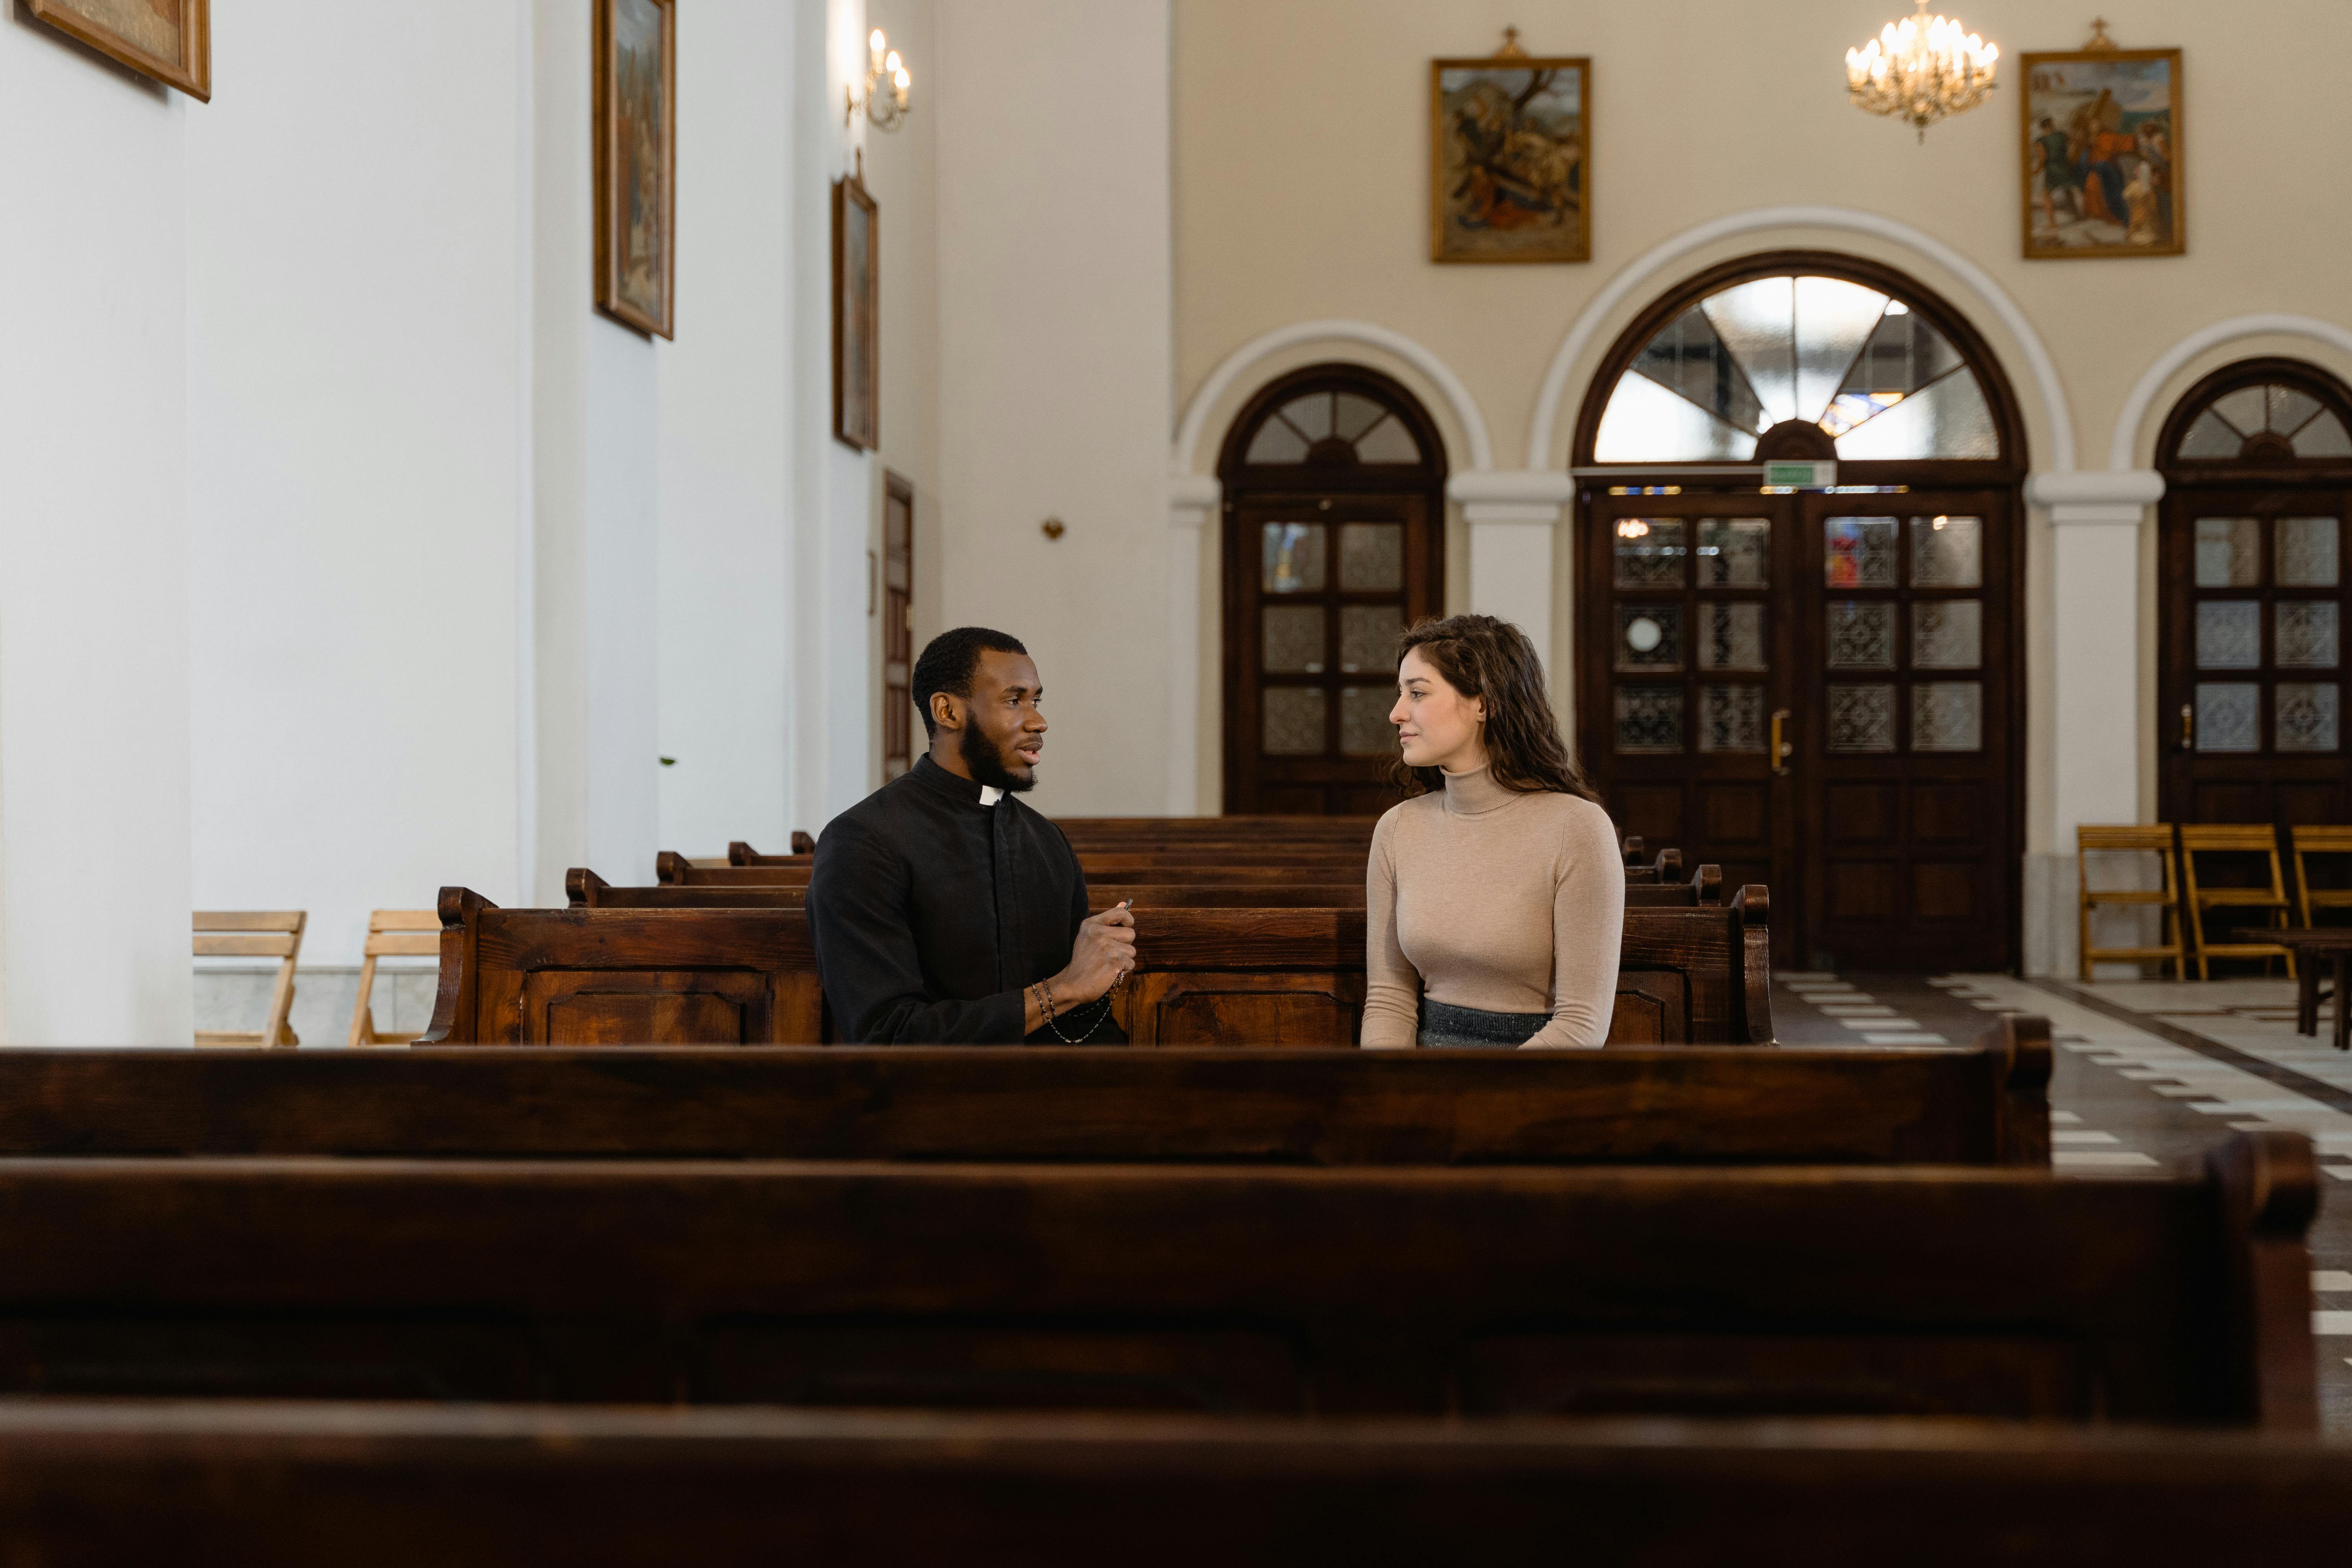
[[1218, 365, 1446, 816]]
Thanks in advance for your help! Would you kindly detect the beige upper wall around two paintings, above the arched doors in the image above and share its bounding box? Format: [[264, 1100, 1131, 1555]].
[[1174, 0, 2352, 849]]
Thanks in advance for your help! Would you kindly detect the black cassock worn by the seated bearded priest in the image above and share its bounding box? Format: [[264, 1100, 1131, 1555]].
[[809, 757, 1127, 1046]]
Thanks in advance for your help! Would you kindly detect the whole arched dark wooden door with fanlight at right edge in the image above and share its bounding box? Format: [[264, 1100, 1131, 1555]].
[[2157, 360, 2352, 825]]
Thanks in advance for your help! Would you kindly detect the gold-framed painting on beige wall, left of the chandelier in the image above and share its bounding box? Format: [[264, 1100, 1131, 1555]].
[[1430, 42, 1592, 261]]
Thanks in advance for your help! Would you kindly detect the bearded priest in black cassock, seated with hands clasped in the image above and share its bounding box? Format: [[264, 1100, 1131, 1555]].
[[809, 625, 1136, 1046]]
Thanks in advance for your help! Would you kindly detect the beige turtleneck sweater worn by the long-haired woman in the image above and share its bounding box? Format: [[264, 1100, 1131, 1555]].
[[1364, 769, 1625, 1048]]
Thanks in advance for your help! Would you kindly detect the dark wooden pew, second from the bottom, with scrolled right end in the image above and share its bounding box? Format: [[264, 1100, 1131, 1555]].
[[0, 1131, 2317, 1432]]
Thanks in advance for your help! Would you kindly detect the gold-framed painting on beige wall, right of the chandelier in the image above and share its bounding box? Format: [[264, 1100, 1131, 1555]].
[[2018, 47, 2187, 261]]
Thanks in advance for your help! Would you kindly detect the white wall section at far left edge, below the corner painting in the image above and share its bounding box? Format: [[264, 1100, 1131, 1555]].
[[0, 18, 193, 1046]]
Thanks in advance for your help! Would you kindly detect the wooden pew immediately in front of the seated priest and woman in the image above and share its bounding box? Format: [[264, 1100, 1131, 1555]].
[[0, 1018, 2051, 1166]]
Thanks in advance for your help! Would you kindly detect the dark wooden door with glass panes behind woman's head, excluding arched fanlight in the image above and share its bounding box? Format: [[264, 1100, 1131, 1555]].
[[1225, 494, 1439, 816]]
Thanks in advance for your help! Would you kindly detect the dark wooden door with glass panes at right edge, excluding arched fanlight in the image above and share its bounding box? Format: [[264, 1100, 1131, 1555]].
[[2157, 496, 2352, 825]]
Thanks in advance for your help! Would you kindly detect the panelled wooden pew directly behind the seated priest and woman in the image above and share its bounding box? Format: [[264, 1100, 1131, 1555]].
[[421, 884, 1774, 1046]]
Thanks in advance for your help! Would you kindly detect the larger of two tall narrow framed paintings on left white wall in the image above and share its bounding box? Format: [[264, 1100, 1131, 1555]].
[[595, 0, 678, 339]]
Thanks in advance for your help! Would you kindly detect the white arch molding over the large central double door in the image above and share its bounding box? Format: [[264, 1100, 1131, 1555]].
[[1527, 205, 2074, 472]]
